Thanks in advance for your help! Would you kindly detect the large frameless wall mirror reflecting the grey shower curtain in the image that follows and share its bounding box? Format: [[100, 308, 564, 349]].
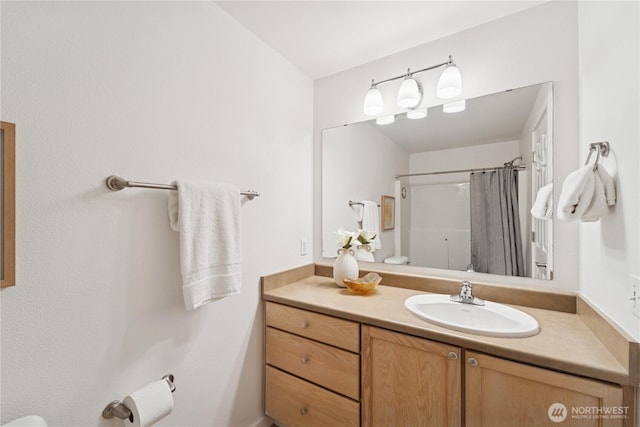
[[322, 82, 553, 279]]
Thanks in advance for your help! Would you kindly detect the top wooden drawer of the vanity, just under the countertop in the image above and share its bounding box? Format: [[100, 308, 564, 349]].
[[266, 302, 360, 353]]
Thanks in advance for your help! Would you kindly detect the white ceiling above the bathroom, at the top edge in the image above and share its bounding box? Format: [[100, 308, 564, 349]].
[[216, 0, 544, 80]]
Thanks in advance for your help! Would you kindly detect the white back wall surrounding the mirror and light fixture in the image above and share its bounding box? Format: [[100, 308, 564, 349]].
[[314, 2, 578, 289]]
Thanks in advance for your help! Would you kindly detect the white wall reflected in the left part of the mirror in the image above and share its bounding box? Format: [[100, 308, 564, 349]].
[[322, 123, 409, 262]]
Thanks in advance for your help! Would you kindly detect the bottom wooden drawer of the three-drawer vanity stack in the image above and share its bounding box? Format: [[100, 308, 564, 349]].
[[265, 366, 360, 427]]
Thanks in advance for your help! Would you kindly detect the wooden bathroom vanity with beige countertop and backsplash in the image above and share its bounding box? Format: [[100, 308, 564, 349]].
[[262, 265, 640, 427]]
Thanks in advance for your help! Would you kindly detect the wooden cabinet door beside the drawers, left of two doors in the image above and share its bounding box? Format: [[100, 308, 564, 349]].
[[362, 326, 462, 427]]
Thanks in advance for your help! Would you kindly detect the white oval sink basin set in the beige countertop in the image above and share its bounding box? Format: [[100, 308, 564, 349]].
[[404, 294, 540, 338]]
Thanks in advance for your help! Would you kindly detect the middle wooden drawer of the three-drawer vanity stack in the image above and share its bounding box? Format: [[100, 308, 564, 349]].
[[266, 328, 360, 400]]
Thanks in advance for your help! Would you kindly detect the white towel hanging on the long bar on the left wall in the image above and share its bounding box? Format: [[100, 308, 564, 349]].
[[169, 181, 241, 310]]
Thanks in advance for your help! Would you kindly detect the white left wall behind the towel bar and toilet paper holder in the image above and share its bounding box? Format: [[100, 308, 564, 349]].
[[0, 2, 313, 427]]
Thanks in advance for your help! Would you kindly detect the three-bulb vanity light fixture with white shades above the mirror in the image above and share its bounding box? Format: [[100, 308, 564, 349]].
[[363, 55, 462, 116]]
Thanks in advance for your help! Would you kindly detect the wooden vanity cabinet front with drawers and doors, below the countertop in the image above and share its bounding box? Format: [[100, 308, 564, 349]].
[[265, 302, 634, 427]]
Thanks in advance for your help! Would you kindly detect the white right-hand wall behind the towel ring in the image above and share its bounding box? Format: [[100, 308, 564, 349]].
[[579, 2, 640, 339]]
